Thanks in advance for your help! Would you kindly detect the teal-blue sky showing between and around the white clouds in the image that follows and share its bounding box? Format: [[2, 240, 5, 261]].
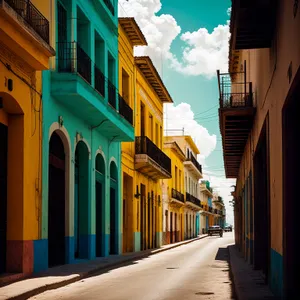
[[159, 0, 230, 175]]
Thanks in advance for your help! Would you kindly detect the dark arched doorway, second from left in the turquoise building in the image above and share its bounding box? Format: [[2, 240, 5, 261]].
[[74, 141, 89, 258]]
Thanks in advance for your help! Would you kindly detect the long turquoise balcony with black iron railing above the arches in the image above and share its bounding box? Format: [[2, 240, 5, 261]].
[[51, 42, 134, 142]]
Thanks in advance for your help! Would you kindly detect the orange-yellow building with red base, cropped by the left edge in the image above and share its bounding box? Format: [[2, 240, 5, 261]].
[[0, 0, 55, 274]]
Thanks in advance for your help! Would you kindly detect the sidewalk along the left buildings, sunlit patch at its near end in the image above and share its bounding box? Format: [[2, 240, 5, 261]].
[[0, 234, 207, 300]]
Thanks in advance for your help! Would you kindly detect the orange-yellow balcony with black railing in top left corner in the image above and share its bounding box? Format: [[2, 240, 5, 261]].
[[0, 0, 55, 70]]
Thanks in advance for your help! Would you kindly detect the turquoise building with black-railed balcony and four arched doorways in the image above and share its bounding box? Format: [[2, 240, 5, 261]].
[[34, 0, 134, 272]]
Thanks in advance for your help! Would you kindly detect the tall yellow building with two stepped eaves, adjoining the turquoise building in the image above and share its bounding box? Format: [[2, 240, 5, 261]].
[[119, 18, 172, 252]]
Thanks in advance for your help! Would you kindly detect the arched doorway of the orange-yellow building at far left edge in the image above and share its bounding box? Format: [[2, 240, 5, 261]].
[[0, 91, 23, 274]]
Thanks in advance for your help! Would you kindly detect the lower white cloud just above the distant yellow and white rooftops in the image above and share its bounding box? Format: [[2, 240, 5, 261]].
[[164, 103, 217, 164]]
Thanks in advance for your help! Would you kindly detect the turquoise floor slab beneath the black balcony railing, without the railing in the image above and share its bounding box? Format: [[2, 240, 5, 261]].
[[51, 72, 134, 142]]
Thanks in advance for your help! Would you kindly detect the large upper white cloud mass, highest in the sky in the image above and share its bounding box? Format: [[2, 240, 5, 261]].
[[119, 0, 229, 78]]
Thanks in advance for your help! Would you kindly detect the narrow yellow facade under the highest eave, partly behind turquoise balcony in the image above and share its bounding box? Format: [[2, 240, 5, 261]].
[[119, 18, 147, 252]]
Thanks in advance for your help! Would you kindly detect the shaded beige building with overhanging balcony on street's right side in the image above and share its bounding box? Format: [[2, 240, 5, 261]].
[[219, 0, 300, 299]]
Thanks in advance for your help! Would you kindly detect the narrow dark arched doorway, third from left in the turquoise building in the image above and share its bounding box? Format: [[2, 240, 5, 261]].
[[95, 154, 105, 257]]
